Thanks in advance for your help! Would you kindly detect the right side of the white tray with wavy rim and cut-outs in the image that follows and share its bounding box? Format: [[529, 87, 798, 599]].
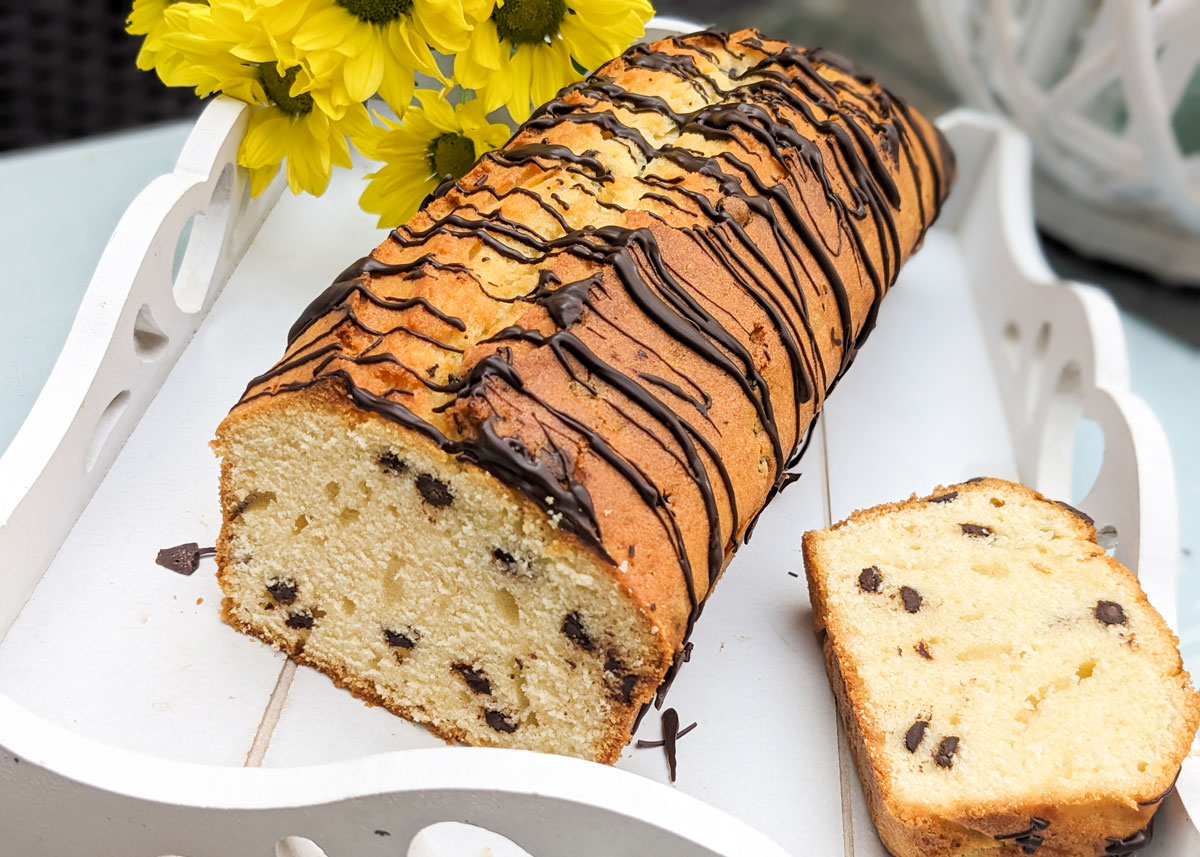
[[938, 110, 1178, 627]]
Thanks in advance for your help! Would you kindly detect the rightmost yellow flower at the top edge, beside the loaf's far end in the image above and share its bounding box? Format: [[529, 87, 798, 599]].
[[454, 0, 654, 122]]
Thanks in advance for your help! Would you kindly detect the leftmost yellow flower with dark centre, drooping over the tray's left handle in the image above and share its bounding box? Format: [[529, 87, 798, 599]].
[[152, 0, 372, 196]]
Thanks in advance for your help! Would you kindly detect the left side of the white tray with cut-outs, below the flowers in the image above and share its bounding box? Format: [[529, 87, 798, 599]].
[[0, 97, 283, 637]]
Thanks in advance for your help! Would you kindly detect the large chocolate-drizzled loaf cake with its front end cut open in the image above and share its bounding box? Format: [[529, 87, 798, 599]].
[[215, 31, 953, 762]]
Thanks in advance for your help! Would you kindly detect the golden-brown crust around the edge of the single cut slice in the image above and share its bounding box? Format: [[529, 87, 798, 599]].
[[803, 479, 1200, 857]]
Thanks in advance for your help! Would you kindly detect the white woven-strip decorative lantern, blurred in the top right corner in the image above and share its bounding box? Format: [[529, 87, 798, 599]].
[[922, 0, 1200, 286]]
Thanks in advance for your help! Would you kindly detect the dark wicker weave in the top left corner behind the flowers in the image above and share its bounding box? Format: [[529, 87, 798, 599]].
[[0, 0, 200, 151]]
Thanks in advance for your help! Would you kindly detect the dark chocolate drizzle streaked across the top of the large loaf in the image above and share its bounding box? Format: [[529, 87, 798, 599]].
[[231, 32, 953, 710]]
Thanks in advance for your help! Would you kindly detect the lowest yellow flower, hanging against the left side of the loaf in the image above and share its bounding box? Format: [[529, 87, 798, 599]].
[[355, 90, 512, 227]]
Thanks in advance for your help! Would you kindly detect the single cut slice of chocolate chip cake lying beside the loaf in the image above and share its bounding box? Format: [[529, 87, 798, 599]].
[[804, 479, 1200, 857]]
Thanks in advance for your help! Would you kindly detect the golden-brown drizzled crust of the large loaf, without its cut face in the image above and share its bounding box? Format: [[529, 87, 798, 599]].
[[218, 30, 953, 758]]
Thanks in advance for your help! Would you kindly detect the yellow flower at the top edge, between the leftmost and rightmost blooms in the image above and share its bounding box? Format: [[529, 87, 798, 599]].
[[292, 0, 479, 114]]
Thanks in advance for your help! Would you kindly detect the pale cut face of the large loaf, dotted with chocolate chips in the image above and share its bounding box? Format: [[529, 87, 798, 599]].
[[218, 396, 670, 762]]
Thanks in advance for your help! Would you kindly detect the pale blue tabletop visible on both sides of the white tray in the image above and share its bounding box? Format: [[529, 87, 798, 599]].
[[0, 122, 1200, 671]]
